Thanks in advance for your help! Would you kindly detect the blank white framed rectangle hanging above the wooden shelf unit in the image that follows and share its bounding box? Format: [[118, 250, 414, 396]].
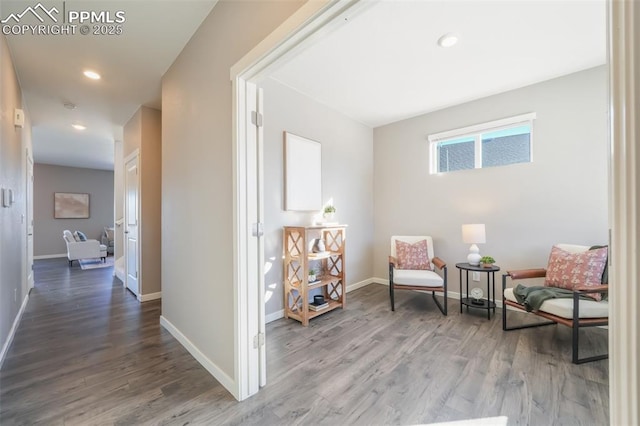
[[284, 132, 322, 211]]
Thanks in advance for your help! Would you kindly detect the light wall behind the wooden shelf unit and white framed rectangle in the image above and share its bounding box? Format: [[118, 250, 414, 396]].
[[260, 79, 373, 315]]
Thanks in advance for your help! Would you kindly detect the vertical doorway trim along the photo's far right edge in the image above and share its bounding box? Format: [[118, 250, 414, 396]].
[[608, 0, 640, 425]]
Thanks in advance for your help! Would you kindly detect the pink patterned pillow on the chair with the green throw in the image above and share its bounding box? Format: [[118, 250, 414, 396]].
[[544, 246, 608, 301]]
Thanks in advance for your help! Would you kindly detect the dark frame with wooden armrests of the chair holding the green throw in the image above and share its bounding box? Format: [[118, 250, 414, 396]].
[[502, 268, 609, 364]]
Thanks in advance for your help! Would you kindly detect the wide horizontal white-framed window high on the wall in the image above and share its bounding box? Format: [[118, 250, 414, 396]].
[[428, 113, 536, 174]]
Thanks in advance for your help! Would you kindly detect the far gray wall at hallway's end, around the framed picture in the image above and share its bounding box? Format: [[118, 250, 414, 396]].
[[33, 163, 114, 256]]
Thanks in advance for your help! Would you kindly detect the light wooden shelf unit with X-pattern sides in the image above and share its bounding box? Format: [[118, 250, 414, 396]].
[[282, 225, 347, 327]]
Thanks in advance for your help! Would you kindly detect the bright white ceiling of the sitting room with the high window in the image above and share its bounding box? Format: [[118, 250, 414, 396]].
[[272, 0, 606, 127]]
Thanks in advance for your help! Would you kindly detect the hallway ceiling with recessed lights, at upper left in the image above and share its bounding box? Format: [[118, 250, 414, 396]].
[[0, 0, 217, 170]]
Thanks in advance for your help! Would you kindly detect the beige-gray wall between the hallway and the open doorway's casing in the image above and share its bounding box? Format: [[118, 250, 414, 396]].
[[162, 1, 303, 385]]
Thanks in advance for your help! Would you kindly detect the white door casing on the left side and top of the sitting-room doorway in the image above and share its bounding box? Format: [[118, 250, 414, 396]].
[[230, 0, 369, 401]]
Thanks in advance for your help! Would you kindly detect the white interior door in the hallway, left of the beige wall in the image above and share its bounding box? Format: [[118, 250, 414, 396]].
[[124, 154, 140, 296]]
